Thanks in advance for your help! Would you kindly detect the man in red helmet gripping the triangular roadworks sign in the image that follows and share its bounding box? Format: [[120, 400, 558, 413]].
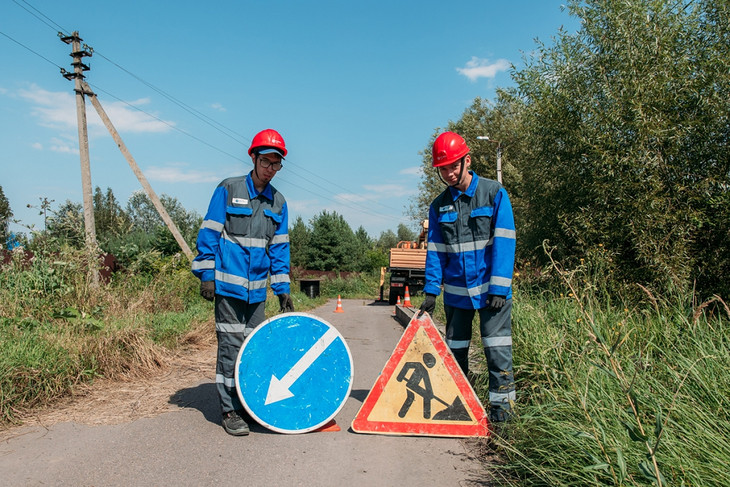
[[421, 132, 515, 422]]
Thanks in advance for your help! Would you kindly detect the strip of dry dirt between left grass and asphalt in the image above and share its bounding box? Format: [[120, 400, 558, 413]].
[[0, 324, 216, 439]]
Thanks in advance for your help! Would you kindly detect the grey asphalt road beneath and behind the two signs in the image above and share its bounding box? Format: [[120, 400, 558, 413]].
[[0, 300, 489, 487]]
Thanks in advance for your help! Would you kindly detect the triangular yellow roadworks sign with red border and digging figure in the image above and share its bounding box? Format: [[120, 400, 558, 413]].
[[352, 311, 489, 437]]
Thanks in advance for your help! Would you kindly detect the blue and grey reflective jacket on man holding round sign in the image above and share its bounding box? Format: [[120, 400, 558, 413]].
[[192, 173, 290, 303]]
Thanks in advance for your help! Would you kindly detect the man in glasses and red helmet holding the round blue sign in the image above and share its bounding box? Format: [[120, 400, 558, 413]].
[[192, 129, 294, 436]]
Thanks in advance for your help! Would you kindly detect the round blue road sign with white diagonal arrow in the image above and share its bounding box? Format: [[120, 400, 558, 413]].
[[236, 313, 353, 433]]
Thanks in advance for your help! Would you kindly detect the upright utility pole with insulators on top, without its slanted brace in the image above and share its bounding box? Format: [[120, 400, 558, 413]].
[[59, 31, 99, 289]]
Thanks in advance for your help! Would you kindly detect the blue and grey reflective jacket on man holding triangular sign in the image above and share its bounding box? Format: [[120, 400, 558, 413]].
[[423, 172, 515, 309]]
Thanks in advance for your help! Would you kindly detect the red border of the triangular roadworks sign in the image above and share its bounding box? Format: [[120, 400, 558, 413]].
[[352, 311, 489, 437]]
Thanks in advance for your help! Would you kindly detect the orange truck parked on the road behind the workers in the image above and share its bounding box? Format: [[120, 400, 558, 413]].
[[388, 220, 428, 304]]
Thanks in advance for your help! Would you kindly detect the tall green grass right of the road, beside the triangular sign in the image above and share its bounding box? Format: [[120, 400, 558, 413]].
[[484, 264, 730, 487]]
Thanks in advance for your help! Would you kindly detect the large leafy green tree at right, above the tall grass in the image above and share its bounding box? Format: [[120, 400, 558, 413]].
[[492, 0, 730, 296]]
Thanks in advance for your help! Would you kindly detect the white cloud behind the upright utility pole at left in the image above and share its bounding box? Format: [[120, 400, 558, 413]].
[[18, 85, 175, 133]]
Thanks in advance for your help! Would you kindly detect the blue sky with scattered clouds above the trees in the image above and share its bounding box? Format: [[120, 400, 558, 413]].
[[0, 0, 578, 237]]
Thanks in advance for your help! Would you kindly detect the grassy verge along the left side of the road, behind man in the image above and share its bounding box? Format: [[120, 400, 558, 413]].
[[0, 247, 384, 425]]
